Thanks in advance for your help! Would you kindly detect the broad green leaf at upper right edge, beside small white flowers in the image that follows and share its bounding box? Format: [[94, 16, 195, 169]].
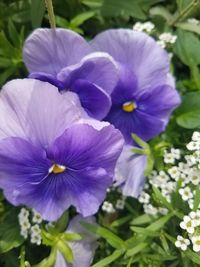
[[174, 30, 200, 66]]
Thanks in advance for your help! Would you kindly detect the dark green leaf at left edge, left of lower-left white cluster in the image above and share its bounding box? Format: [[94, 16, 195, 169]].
[[0, 209, 24, 253]]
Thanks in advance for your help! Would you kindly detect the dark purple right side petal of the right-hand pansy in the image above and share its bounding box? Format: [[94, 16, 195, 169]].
[[138, 85, 181, 121]]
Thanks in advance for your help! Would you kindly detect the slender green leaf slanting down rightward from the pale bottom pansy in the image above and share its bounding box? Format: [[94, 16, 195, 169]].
[[81, 222, 125, 248]]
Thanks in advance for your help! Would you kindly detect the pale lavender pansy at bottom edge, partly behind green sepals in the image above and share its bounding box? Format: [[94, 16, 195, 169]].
[[54, 215, 98, 267]]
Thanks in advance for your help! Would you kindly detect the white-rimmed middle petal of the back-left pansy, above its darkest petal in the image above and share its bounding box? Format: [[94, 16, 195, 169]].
[[57, 52, 118, 94]]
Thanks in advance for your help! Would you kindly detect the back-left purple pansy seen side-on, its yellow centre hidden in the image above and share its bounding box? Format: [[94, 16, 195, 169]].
[[23, 29, 118, 120]]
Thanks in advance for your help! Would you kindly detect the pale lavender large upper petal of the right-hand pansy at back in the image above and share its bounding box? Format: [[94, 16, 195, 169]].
[[91, 29, 169, 90]]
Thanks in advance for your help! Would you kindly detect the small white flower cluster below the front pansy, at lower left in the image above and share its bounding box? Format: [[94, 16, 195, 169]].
[[18, 208, 42, 246]]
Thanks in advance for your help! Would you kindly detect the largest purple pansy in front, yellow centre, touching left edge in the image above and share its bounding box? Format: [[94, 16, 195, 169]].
[[0, 79, 123, 220]]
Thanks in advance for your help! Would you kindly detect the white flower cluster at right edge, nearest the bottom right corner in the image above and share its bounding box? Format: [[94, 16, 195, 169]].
[[175, 210, 200, 252]]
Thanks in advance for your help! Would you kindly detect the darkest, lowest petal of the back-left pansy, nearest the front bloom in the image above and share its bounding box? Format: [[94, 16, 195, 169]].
[[71, 79, 111, 120]]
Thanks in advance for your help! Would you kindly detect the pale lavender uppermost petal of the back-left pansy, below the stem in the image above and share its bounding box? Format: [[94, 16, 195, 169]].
[[23, 29, 91, 76]]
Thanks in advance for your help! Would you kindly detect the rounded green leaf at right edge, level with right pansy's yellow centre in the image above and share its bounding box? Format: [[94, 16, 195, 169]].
[[176, 92, 200, 129]]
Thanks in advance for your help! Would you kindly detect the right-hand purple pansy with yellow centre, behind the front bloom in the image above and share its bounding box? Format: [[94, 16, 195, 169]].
[[91, 29, 180, 143]]
